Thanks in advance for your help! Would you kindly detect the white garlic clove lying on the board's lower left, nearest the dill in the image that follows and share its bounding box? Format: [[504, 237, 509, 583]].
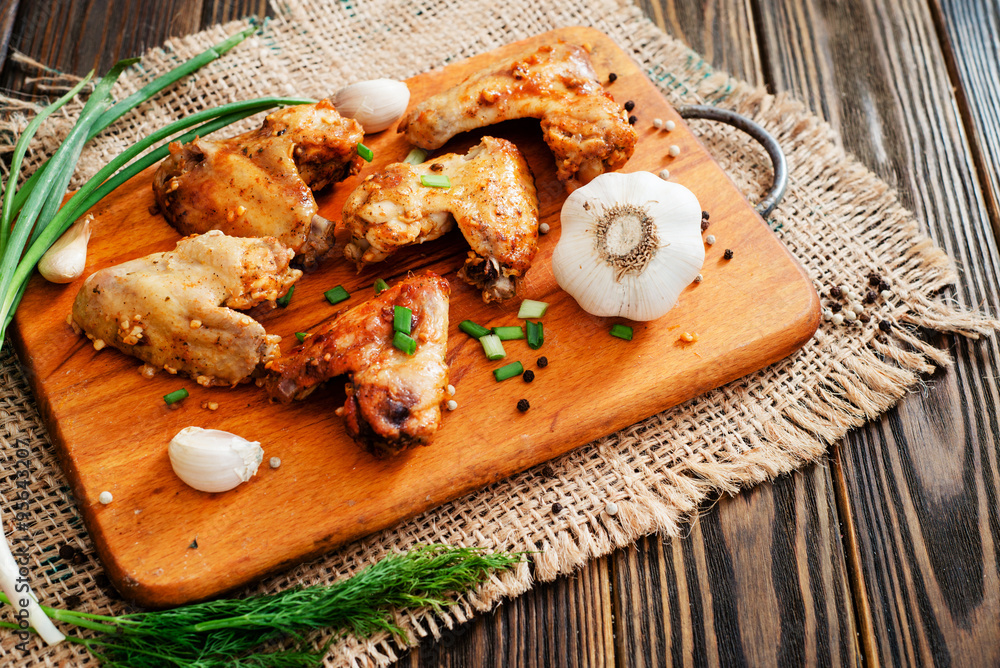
[[167, 427, 264, 492]]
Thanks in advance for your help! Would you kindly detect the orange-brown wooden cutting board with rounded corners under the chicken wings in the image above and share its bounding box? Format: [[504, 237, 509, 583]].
[[13, 28, 819, 606]]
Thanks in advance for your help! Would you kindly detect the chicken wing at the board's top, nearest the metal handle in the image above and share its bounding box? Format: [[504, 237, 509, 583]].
[[399, 42, 636, 191]]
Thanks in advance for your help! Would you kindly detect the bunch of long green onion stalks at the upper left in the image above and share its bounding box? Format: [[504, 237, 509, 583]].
[[0, 27, 315, 346]]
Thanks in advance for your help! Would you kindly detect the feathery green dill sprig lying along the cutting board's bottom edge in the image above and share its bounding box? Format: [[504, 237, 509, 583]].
[[0, 545, 523, 668]]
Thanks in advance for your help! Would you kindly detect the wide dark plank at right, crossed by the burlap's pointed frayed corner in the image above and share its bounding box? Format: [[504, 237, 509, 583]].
[[761, 0, 1000, 665]]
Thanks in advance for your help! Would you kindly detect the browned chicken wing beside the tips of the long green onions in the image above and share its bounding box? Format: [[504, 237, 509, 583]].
[[153, 100, 364, 267]]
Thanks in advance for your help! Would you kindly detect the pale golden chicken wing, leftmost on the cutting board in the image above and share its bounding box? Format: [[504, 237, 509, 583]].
[[72, 231, 302, 386]]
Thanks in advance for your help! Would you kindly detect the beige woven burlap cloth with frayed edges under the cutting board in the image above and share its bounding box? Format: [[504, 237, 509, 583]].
[[0, 0, 993, 666]]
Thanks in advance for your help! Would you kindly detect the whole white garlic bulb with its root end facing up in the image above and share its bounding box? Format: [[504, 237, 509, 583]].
[[552, 172, 705, 320]]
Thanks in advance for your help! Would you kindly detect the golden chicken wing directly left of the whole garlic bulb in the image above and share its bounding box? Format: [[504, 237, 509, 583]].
[[343, 137, 538, 302]]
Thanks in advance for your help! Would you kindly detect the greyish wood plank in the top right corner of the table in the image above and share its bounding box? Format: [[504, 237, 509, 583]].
[[931, 0, 1000, 235]]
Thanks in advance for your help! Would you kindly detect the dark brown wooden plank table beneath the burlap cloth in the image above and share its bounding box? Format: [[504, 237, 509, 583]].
[[0, 0, 1000, 666]]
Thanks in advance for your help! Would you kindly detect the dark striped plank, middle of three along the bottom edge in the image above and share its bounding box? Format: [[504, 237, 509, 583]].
[[612, 472, 859, 667]]
